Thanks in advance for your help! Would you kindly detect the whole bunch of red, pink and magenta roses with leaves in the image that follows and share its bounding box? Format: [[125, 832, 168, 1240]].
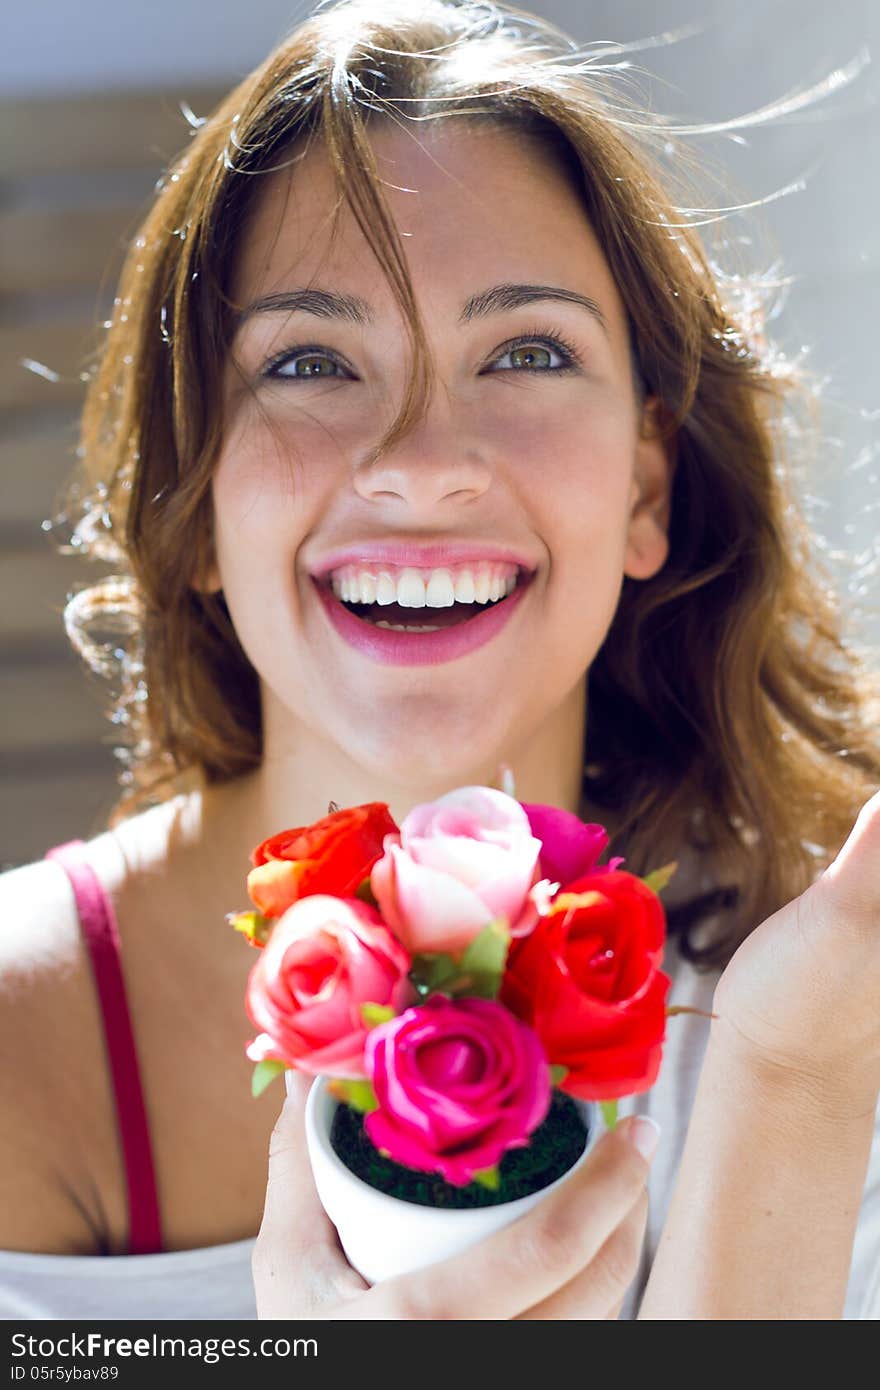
[[228, 787, 677, 1200]]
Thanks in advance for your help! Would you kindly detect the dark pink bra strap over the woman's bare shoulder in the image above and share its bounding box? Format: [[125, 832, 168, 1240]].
[[46, 840, 161, 1255]]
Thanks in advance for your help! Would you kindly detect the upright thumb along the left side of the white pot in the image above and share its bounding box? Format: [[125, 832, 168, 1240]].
[[252, 1072, 368, 1318]]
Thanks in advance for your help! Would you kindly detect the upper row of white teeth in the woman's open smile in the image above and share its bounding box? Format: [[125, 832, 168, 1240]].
[[331, 563, 517, 609]]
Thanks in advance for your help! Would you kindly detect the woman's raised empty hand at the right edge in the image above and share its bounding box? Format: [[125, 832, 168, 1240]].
[[713, 792, 880, 1112]]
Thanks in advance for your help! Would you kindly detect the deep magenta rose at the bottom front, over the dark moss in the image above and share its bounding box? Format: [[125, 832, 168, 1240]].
[[364, 994, 551, 1187]]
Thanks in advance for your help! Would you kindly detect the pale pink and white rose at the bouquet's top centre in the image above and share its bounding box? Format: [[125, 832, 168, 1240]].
[[370, 787, 541, 955]]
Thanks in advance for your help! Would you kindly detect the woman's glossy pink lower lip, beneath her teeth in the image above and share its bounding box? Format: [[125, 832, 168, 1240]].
[[314, 569, 531, 666]]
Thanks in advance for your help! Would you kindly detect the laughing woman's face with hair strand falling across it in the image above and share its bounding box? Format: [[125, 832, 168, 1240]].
[[209, 122, 669, 785]]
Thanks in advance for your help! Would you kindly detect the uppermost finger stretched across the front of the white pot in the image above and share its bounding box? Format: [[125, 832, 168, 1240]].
[[358, 1116, 656, 1319]]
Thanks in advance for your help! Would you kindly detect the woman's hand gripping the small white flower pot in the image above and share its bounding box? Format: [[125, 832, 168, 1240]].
[[253, 1073, 656, 1321]]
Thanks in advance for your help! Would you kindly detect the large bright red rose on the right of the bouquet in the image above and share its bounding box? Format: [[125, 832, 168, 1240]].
[[499, 869, 670, 1101]]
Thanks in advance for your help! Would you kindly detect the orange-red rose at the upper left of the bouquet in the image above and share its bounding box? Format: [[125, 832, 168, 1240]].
[[247, 801, 399, 917]]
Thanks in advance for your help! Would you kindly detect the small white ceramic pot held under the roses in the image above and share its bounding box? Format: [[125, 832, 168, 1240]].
[[306, 1076, 601, 1284]]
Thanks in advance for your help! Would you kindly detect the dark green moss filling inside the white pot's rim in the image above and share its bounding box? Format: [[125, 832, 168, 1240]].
[[329, 1090, 587, 1208]]
